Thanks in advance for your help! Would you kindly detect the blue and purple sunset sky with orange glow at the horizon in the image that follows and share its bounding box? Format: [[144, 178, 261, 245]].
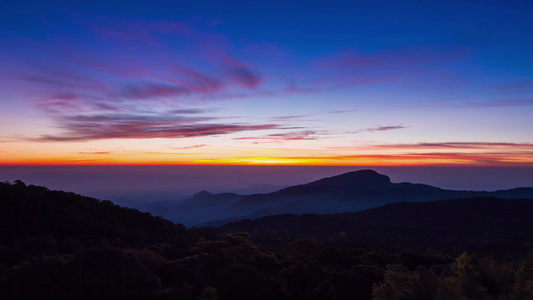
[[0, 0, 533, 166]]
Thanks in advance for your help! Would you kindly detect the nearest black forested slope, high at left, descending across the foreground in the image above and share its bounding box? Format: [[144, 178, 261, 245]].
[[0, 181, 533, 300]]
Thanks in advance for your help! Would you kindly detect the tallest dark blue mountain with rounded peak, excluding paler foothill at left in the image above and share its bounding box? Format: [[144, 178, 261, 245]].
[[227, 170, 533, 218]]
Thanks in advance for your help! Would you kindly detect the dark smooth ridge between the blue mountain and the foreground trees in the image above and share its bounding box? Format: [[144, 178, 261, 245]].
[[219, 197, 533, 253]]
